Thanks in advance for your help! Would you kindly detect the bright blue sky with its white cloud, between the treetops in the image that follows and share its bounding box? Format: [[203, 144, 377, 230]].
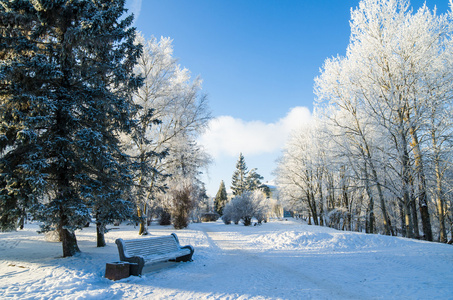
[[127, 0, 448, 196]]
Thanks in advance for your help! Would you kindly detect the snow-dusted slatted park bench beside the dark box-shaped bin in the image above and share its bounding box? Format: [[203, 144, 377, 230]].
[[115, 233, 194, 276]]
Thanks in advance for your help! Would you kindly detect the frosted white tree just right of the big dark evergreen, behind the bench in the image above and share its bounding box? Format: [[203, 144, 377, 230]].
[[123, 35, 210, 234]]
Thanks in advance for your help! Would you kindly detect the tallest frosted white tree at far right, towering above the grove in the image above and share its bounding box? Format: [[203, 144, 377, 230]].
[[318, 0, 451, 240]]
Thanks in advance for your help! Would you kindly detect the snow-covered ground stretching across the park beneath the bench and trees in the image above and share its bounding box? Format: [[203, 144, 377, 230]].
[[0, 219, 453, 299]]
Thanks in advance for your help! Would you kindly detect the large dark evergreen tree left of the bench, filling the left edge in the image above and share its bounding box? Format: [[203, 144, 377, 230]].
[[0, 0, 141, 256]]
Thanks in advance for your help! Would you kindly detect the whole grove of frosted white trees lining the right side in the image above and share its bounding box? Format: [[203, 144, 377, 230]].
[[277, 0, 453, 241]]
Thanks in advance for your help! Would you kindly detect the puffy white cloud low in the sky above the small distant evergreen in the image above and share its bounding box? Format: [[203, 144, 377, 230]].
[[199, 107, 311, 158]]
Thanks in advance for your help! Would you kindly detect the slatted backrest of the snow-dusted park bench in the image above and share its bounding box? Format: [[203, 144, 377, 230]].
[[123, 235, 180, 257]]
